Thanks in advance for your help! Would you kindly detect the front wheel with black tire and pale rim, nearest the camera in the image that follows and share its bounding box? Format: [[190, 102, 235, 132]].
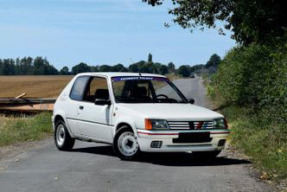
[[113, 125, 140, 160]]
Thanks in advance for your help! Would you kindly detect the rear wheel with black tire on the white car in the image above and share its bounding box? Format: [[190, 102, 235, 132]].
[[54, 120, 75, 151]]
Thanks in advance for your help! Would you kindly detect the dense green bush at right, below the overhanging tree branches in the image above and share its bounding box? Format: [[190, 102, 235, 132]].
[[210, 44, 287, 122]]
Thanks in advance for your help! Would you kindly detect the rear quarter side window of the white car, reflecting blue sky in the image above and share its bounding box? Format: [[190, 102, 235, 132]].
[[70, 76, 89, 101]]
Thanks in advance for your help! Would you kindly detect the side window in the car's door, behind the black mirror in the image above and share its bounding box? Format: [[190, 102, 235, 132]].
[[83, 77, 109, 102]]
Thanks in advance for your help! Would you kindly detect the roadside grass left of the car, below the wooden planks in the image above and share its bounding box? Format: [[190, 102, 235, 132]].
[[0, 113, 53, 147]]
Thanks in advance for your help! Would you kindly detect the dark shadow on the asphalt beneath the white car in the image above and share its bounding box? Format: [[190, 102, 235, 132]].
[[72, 146, 250, 166]]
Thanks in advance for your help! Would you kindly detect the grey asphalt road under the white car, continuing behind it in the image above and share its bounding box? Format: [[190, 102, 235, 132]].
[[0, 78, 273, 192]]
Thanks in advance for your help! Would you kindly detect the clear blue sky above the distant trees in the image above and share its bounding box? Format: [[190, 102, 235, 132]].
[[0, 0, 235, 69]]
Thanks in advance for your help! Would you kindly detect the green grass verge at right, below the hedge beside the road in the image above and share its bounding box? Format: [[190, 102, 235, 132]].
[[221, 106, 287, 180]]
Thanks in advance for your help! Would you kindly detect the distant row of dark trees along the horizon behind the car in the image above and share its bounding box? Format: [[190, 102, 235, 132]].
[[0, 54, 221, 77]]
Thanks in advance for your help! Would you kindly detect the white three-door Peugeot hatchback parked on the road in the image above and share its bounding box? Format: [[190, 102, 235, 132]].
[[52, 73, 229, 160]]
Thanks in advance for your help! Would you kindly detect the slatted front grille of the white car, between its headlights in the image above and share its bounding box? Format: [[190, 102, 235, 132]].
[[167, 121, 213, 130]]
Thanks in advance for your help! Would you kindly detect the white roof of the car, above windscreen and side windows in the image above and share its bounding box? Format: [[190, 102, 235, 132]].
[[77, 72, 166, 78]]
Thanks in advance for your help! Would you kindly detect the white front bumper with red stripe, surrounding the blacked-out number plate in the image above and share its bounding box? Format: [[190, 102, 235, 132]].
[[137, 129, 230, 152]]
